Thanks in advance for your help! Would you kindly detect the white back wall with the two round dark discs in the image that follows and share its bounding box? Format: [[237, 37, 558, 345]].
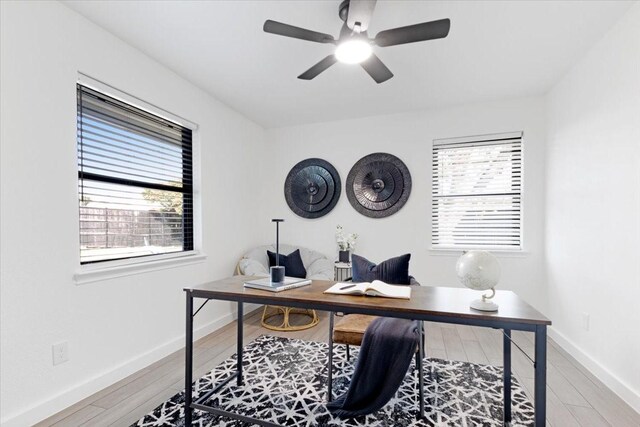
[[266, 98, 546, 309]]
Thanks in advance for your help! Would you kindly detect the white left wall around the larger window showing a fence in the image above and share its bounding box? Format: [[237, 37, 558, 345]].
[[0, 2, 268, 425]]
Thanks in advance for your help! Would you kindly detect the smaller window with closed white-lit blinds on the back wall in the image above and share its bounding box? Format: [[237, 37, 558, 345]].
[[431, 132, 522, 250]]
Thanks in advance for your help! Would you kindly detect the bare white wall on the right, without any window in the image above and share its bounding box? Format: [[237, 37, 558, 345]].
[[546, 4, 640, 411]]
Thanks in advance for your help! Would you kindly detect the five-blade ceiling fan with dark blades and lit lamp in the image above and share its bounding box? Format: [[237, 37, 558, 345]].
[[263, 0, 451, 83]]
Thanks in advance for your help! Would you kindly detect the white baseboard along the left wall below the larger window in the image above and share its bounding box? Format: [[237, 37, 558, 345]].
[[0, 304, 259, 427]]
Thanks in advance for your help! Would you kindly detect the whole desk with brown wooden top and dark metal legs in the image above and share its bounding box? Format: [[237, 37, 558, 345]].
[[184, 276, 551, 427]]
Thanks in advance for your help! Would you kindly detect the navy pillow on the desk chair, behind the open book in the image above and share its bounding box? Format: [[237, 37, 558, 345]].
[[351, 254, 411, 285]]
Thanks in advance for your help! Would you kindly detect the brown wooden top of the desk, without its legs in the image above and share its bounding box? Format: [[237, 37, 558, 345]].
[[184, 276, 551, 325]]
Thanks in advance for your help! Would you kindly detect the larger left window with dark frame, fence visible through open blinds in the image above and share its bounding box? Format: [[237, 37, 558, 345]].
[[77, 84, 193, 264]]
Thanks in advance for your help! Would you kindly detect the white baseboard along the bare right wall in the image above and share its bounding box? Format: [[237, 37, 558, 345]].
[[549, 327, 640, 413]]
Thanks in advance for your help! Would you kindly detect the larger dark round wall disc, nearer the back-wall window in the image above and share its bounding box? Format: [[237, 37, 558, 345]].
[[346, 153, 411, 218]]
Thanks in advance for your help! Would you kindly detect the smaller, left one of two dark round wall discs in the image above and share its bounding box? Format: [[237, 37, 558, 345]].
[[284, 159, 342, 218]]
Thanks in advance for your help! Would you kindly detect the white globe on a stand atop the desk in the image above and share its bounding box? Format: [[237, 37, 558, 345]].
[[456, 251, 501, 311]]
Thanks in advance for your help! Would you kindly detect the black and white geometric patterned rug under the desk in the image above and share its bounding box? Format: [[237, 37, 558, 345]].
[[133, 336, 533, 427]]
